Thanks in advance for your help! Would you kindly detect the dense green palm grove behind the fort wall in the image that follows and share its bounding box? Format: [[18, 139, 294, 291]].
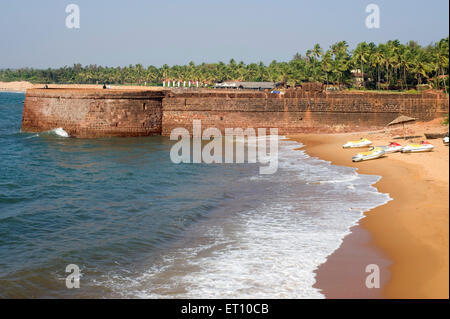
[[0, 37, 449, 92]]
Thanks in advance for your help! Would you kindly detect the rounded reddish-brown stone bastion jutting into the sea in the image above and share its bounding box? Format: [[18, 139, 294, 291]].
[[22, 89, 164, 138]]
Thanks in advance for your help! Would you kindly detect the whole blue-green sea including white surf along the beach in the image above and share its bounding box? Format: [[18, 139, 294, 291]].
[[0, 92, 390, 298]]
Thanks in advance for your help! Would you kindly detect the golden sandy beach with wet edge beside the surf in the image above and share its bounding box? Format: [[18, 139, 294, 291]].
[[291, 120, 449, 299]]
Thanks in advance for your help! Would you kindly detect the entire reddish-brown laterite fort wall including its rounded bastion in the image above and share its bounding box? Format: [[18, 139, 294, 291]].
[[22, 89, 449, 138]]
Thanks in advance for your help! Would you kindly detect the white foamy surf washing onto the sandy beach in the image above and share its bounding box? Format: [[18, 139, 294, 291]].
[[103, 141, 389, 298]]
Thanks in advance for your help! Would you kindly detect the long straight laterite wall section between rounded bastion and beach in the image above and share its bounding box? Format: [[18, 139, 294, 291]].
[[162, 90, 448, 135]]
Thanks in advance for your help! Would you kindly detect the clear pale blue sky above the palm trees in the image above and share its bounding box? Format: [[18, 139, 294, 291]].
[[0, 0, 449, 68]]
